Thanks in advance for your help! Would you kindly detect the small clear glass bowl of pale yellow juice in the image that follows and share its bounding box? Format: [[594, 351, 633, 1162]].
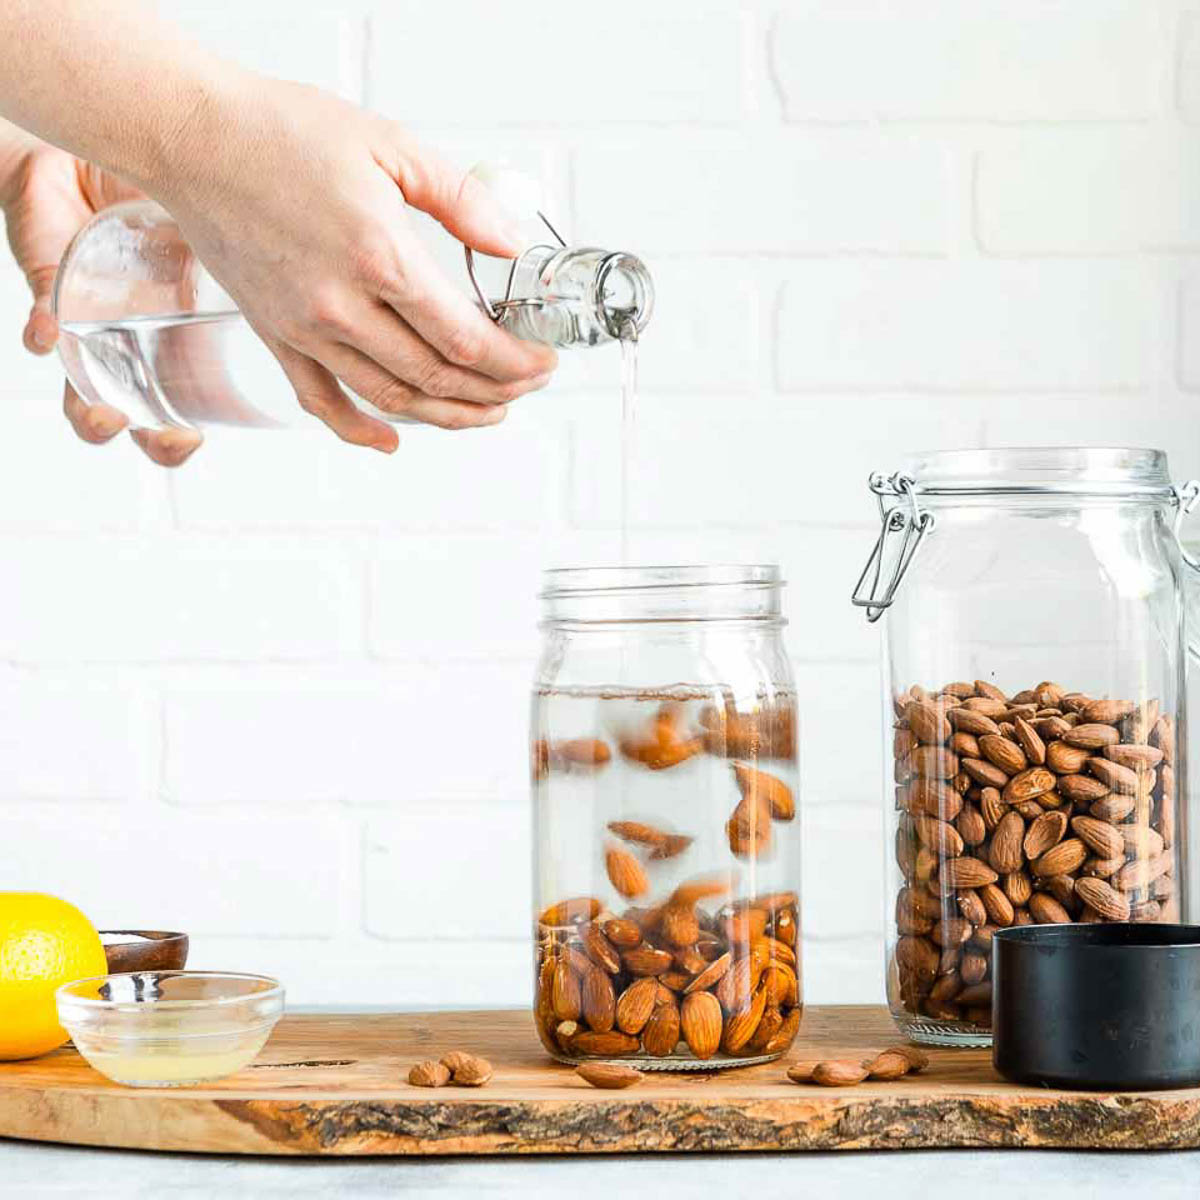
[[55, 971, 283, 1087]]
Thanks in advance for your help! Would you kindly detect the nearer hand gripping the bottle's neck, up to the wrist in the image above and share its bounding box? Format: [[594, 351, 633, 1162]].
[[143, 76, 557, 452]]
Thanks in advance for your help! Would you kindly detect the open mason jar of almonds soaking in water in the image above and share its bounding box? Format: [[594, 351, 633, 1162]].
[[532, 566, 800, 1069]]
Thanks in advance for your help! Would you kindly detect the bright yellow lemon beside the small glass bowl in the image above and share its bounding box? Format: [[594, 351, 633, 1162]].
[[0, 892, 108, 1058]]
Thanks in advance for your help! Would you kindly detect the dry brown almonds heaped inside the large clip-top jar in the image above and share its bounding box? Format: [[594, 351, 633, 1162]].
[[887, 680, 1180, 1032]]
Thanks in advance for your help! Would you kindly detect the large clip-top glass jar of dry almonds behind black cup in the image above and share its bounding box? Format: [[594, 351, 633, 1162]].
[[856, 449, 1196, 1045]]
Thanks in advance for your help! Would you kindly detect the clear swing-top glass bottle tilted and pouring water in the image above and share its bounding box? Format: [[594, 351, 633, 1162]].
[[53, 200, 654, 439]]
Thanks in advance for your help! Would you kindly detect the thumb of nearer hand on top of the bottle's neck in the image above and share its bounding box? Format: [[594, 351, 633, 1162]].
[[397, 146, 526, 258]]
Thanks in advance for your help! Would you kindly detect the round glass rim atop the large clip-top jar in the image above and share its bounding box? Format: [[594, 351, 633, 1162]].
[[900, 446, 1175, 500]]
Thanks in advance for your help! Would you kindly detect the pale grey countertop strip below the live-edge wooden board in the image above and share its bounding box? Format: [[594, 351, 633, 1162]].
[[0, 1141, 1200, 1200]]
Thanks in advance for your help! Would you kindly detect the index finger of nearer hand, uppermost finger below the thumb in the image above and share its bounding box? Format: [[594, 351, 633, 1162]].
[[382, 236, 558, 383]]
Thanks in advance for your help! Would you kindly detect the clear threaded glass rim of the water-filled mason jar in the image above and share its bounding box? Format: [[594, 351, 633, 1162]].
[[541, 564, 785, 625]]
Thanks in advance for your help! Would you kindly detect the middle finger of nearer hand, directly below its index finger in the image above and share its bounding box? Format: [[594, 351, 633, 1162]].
[[343, 305, 550, 404]]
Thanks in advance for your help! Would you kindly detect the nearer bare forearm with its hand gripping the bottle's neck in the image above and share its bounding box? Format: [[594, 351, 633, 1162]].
[[0, 0, 556, 450]]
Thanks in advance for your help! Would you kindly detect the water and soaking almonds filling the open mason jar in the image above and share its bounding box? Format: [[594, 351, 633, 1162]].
[[532, 692, 802, 1069]]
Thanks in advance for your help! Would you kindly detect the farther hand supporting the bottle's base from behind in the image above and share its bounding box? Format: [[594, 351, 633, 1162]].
[[0, 121, 202, 467]]
